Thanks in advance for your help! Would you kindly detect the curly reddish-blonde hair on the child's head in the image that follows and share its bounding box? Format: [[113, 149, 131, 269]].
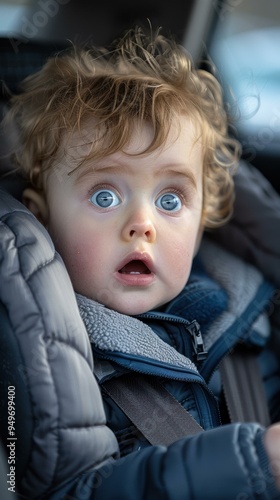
[[5, 28, 239, 228]]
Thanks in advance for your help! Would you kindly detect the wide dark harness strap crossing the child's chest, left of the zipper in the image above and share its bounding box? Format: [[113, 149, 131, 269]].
[[102, 373, 203, 446]]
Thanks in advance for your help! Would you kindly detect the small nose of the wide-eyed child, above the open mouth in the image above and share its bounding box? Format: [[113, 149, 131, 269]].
[[122, 206, 156, 243]]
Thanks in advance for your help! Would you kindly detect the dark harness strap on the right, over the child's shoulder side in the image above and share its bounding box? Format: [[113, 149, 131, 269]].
[[219, 348, 270, 427]]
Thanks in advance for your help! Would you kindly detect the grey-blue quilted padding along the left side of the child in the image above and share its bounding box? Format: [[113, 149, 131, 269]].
[[0, 191, 117, 499]]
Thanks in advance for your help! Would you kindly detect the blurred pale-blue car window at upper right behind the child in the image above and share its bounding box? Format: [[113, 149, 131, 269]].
[[208, 0, 280, 161]]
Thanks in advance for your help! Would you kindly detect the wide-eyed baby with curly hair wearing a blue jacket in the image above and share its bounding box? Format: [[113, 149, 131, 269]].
[[4, 29, 280, 498]]
